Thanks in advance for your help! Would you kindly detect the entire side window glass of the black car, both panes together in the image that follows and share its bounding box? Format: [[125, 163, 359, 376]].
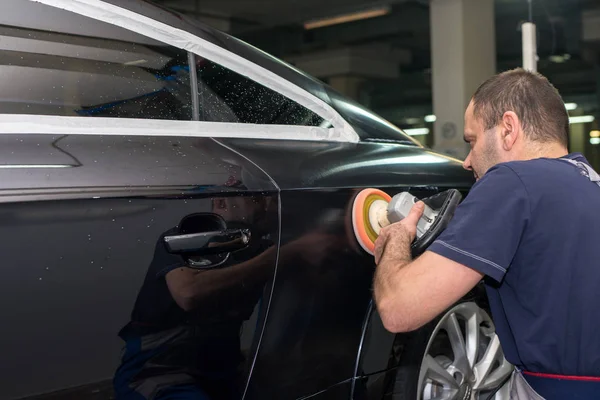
[[0, 0, 324, 126]]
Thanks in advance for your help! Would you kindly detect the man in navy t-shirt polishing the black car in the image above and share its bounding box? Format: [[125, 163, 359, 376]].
[[374, 69, 600, 400]]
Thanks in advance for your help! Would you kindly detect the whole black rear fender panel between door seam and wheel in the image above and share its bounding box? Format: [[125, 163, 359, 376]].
[[216, 135, 468, 399]]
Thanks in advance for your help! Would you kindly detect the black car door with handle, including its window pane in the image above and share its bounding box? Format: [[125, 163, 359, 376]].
[[0, 0, 280, 400]]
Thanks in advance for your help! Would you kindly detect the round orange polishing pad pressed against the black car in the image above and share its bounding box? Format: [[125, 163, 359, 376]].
[[352, 189, 392, 255]]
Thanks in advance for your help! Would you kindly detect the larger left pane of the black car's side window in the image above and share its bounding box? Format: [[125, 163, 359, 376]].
[[0, 0, 193, 120]]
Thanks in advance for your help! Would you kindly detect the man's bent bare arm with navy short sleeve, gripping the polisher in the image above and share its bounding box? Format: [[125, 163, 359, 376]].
[[374, 167, 530, 332]]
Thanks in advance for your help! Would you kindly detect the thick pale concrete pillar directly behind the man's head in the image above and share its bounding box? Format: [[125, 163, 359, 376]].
[[430, 0, 496, 160]]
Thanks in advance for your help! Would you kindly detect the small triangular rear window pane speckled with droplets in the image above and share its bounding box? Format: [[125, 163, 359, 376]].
[[196, 56, 323, 126]]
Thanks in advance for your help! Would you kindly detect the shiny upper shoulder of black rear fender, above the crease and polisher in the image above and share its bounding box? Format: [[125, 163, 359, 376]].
[[219, 139, 473, 194]]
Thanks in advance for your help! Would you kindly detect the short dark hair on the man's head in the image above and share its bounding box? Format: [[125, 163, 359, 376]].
[[472, 68, 569, 147]]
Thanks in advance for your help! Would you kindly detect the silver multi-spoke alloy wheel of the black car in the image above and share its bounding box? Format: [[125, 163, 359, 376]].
[[418, 302, 513, 400]]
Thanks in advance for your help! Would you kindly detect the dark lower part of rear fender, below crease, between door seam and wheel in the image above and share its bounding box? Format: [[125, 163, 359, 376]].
[[244, 190, 373, 398]]
